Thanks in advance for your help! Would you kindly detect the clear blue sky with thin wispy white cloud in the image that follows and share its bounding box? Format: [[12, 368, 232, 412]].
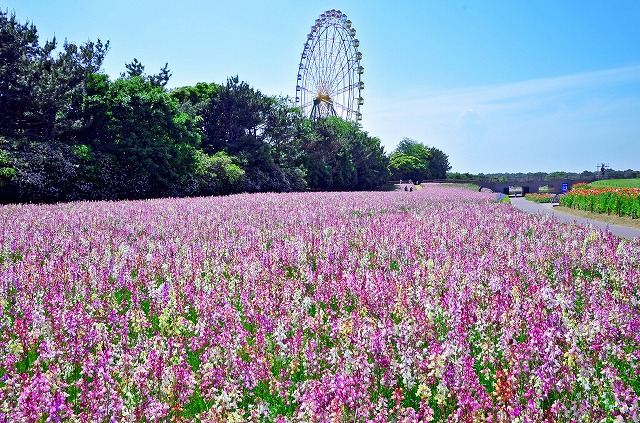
[[6, 0, 640, 173]]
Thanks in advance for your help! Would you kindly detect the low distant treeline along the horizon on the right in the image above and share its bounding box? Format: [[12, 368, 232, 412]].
[[447, 168, 640, 182]]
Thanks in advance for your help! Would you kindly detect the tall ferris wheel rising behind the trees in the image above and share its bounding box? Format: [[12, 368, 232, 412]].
[[296, 9, 364, 121]]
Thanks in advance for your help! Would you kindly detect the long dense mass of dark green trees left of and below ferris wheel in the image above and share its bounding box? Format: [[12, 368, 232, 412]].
[[0, 11, 390, 203]]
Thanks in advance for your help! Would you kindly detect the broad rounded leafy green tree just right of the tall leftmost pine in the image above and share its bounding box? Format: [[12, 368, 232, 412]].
[[83, 70, 199, 198]]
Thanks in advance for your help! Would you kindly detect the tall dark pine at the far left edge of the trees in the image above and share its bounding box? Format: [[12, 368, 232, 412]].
[[0, 11, 109, 141]]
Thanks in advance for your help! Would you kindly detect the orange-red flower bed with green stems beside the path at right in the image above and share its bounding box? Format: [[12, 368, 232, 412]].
[[560, 185, 640, 218]]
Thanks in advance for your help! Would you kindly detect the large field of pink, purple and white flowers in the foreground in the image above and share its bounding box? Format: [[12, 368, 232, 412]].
[[0, 187, 640, 422]]
